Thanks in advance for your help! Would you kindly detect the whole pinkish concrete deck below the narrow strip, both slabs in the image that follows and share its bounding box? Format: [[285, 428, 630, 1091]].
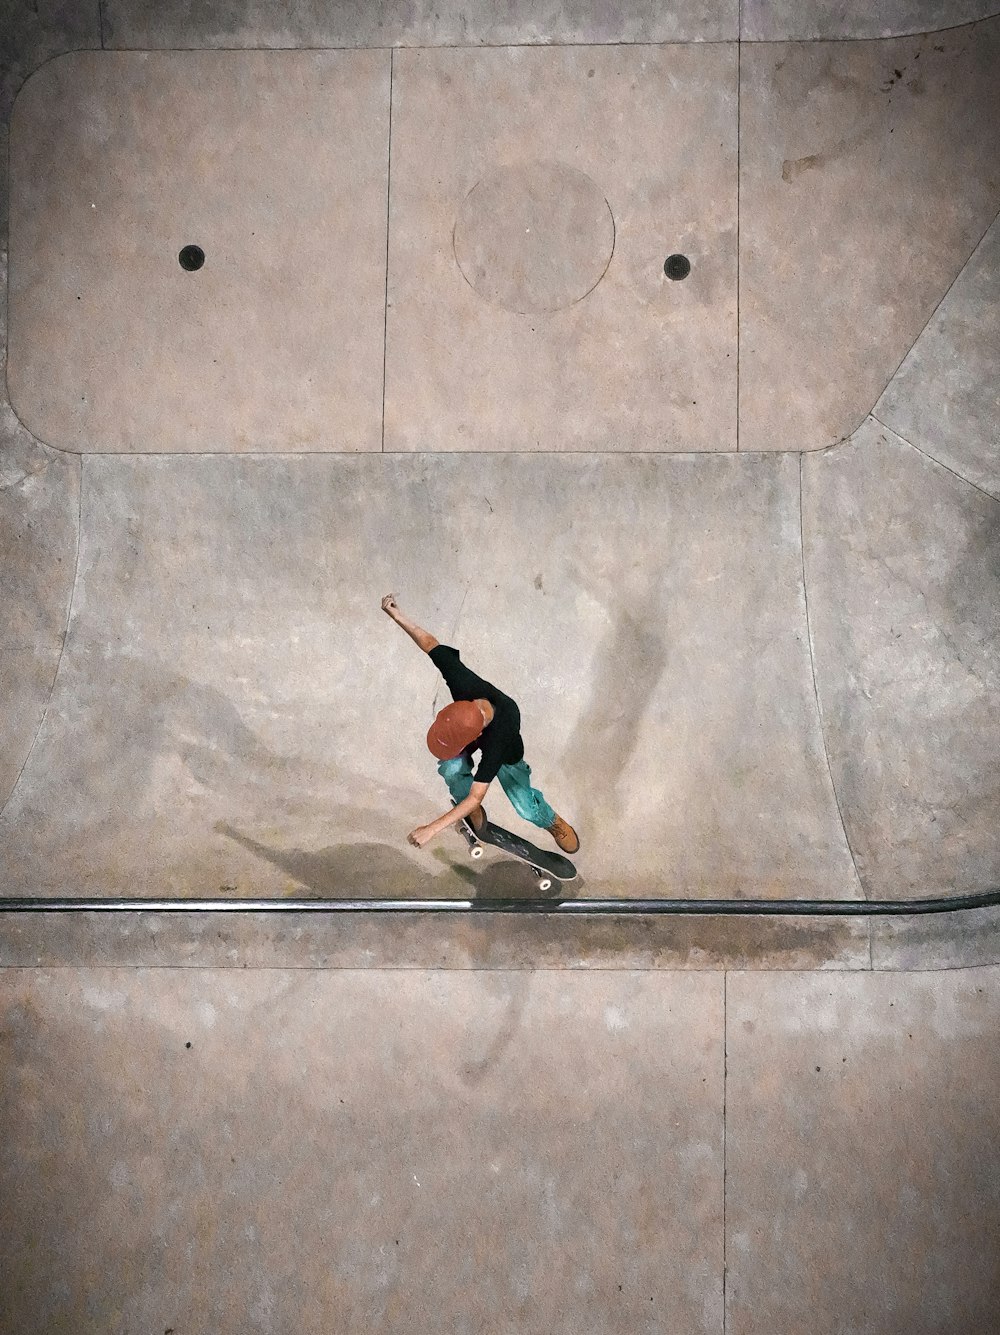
[[0, 969, 1000, 1335]]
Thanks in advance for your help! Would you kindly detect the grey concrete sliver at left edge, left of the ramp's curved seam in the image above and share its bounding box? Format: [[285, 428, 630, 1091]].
[[0, 246, 81, 814]]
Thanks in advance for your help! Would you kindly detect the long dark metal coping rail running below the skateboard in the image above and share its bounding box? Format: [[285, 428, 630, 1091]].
[[0, 888, 1000, 917]]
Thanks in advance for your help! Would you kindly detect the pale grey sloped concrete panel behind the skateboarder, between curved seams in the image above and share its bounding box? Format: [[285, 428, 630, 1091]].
[[1, 455, 858, 897]]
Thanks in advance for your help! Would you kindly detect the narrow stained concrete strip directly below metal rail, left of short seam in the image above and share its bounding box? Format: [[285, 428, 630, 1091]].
[[0, 907, 870, 971]]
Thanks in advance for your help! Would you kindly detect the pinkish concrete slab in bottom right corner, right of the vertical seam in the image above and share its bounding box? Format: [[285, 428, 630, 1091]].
[[726, 969, 1000, 1335]]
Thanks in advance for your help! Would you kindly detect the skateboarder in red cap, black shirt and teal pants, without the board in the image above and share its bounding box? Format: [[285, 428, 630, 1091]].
[[382, 593, 579, 853]]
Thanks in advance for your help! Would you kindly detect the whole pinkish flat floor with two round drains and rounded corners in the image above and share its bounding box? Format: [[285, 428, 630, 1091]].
[[9, 31, 1000, 451]]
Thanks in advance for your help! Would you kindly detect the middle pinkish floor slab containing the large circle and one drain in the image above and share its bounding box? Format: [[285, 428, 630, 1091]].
[[386, 45, 737, 451]]
